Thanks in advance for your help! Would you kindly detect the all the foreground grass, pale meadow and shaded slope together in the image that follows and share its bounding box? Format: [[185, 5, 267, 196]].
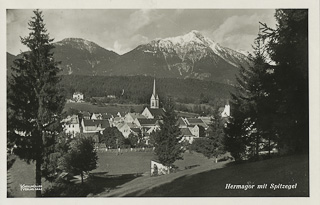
[[7, 150, 309, 197]]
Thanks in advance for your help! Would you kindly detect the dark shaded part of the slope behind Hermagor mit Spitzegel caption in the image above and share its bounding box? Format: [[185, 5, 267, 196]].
[[138, 156, 309, 196]]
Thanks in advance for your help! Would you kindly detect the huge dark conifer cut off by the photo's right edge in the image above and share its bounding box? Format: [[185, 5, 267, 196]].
[[260, 9, 309, 153]]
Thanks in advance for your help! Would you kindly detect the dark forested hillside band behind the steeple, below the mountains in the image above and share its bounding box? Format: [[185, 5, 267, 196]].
[[61, 75, 234, 104]]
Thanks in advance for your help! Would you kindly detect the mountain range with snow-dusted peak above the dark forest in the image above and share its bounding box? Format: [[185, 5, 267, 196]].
[[7, 31, 250, 85]]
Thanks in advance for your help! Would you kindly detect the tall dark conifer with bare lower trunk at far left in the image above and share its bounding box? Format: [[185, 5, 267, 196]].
[[7, 10, 64, 197]]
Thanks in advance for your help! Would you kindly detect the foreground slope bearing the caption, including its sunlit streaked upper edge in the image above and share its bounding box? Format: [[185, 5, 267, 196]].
[[98, 155, 309, 197]]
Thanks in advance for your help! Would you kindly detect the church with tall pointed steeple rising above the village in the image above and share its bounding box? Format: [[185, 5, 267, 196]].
[[142, 79, 164, 119]]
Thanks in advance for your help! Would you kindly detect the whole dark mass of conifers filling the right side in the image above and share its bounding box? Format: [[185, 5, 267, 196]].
[[226, 9, 309, 160]]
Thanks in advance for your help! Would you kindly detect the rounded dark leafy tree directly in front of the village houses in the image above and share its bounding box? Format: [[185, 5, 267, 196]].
[[100, 127, 125, 149]]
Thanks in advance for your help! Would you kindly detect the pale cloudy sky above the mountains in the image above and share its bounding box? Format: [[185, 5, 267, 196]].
[[6, 9, 276, 55]]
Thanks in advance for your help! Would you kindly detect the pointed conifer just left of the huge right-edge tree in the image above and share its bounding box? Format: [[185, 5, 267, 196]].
[[225, 38, 273, 160]]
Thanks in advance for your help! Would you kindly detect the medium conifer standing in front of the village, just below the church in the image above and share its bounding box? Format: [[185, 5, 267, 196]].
[[153, 98, 183, 170]]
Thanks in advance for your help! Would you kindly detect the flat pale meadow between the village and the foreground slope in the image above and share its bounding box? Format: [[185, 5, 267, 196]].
[[7, 150, 211, 197]]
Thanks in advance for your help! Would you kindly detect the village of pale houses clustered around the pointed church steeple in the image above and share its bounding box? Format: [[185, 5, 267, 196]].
[[62, 79, 230, 150]]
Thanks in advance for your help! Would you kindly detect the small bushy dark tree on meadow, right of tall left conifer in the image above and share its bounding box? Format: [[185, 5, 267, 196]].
[[61, 136, 98, 183]]
